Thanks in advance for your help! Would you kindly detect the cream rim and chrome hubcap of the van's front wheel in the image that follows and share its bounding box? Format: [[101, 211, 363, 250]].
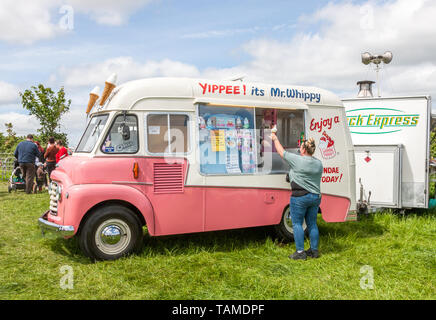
[[95, 219, 132, 255]]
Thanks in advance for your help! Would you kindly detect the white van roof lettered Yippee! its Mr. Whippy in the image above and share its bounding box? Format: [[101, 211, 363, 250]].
[[99, 78, 343, 110]]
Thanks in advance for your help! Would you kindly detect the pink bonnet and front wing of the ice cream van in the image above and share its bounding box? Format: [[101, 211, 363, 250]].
[[48, 157, 154, 235]]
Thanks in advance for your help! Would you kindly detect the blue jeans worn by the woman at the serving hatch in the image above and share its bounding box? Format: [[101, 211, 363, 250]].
[[290, 193, 321, 251]]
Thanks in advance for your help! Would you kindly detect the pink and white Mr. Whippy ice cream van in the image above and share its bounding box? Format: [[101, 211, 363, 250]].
[[39, 77, 356, 259]]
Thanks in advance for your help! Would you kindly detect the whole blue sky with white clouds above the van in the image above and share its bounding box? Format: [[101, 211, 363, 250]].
[[0, 0, 436, 142]]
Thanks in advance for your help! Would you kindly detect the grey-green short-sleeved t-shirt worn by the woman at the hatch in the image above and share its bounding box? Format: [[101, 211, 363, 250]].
[[283, 151, 323, 194]]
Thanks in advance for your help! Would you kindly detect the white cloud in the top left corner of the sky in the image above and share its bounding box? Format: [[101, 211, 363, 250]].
[[0, 0, 156, 44]]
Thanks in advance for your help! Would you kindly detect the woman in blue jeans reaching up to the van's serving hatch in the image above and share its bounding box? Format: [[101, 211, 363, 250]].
[[271, 133, 323, 260]]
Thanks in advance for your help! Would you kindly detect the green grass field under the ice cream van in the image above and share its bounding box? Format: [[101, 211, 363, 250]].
[[0, 183, 436, 299]]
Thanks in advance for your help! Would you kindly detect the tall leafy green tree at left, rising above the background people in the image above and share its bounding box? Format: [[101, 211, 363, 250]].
[[20, 84, 71, 145]]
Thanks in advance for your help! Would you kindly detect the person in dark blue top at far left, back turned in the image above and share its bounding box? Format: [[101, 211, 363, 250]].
[[14, 134, 39, 194]]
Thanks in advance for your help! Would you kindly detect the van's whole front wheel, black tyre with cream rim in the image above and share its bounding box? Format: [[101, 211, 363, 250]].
[[79, 205, 143, 260]]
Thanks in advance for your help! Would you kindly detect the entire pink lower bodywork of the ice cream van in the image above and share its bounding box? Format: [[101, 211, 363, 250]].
[[48, 156, 350, 236]]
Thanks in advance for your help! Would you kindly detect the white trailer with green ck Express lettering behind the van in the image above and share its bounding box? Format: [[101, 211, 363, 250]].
[[342, 96, 432, 209]]
